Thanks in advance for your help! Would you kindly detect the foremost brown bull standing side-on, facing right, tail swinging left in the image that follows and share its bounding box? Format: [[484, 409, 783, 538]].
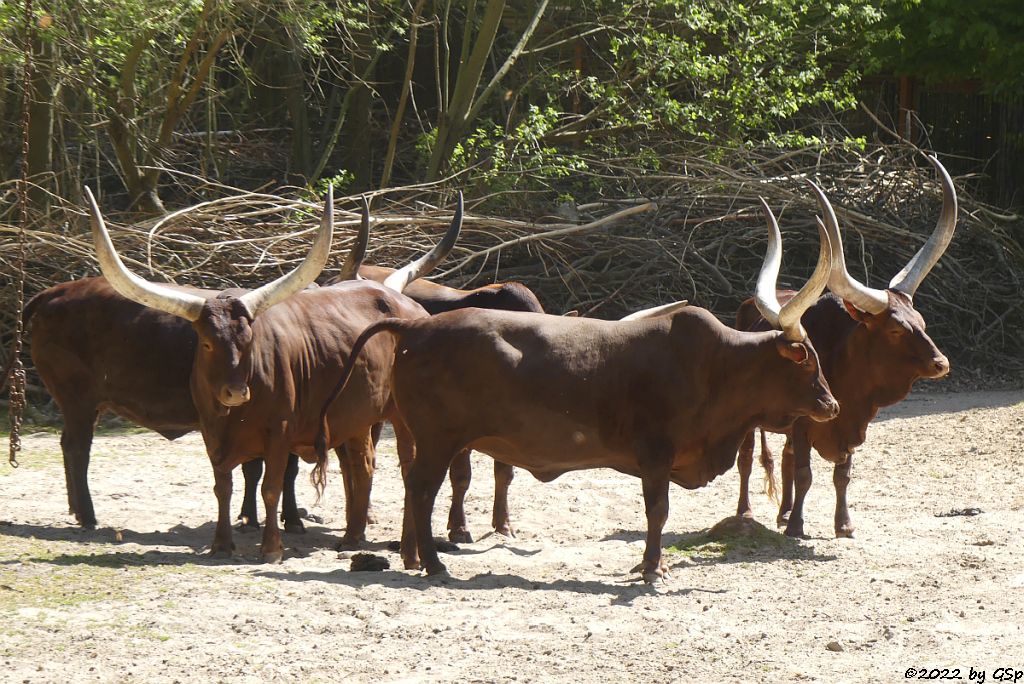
[[317, 202, 839, 581]]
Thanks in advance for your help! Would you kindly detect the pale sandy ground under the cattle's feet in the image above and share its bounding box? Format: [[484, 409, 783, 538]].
[[0, 391, 1024, 682]]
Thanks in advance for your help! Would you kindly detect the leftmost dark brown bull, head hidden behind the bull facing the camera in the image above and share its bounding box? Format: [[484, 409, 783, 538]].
[[14, 200, 369, 528]]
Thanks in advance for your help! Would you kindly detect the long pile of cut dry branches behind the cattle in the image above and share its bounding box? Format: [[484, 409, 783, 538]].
[[0, 145, 1024, 405]]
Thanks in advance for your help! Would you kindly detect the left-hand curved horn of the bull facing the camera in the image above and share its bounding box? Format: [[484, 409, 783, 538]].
[[85, 185, 206, 320]]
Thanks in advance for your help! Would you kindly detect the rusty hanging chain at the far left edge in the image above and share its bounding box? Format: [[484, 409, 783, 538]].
[[7, 0, 35, 468]]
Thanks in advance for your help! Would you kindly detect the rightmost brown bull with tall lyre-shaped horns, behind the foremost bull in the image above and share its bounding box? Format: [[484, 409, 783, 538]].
[[736, 157, 956, 537]]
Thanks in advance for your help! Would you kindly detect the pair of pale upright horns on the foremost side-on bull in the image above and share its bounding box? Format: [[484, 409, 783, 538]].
[[754, 198, 831, 342]]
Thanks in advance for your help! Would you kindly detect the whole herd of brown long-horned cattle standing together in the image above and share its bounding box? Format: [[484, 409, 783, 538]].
[[6, 157, 956, 583]]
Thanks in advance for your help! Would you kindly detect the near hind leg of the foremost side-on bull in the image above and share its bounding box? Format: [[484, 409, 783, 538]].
[[402, 439, 459, 574]]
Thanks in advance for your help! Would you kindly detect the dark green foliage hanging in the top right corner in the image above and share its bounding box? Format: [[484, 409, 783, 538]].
[[873, 0, 1024, 95]]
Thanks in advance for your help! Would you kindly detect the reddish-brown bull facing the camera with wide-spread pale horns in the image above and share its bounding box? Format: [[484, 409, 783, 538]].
[[87, 187, 461, 562]]
